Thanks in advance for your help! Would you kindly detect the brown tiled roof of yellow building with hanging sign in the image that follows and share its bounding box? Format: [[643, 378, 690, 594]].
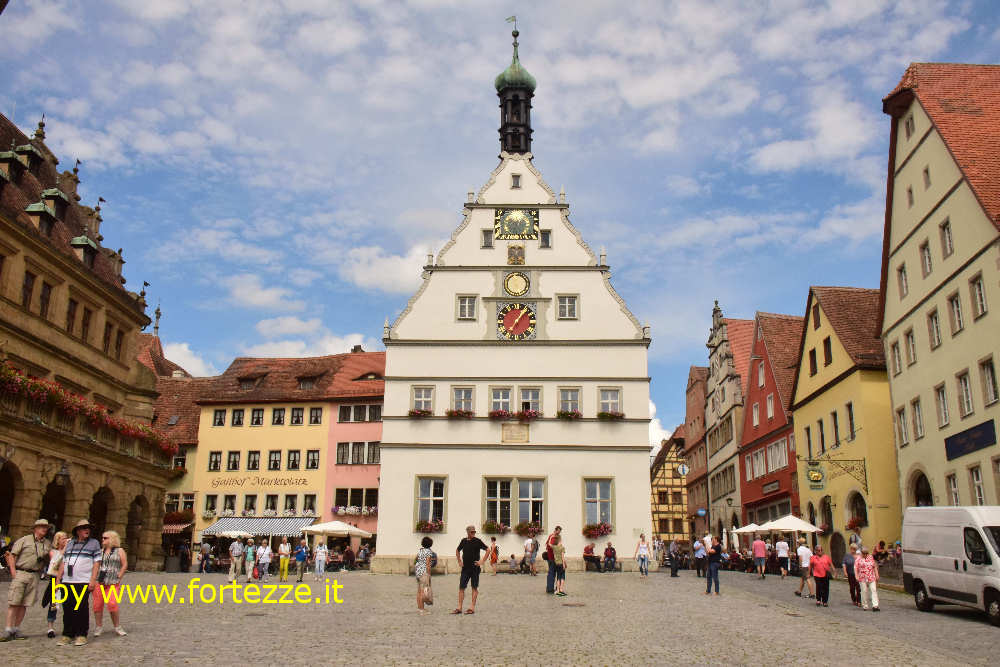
[[812, 286, 885, 370]]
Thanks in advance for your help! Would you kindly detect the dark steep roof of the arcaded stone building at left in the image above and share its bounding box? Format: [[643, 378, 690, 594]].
[[0, 114, 144, 312]]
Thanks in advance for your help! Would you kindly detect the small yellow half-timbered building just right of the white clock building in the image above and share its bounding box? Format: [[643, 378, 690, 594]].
[[649, 434, 688, 545]]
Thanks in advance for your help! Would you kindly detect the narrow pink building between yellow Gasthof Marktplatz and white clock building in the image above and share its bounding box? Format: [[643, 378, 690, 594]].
[[320, 346, 385, 549]]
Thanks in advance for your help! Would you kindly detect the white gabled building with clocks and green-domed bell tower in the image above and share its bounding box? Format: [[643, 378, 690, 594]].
[[372, 31, 652, 572]]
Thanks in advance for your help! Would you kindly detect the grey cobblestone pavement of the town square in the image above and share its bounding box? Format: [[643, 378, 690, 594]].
[[0, 572, 988, 665]]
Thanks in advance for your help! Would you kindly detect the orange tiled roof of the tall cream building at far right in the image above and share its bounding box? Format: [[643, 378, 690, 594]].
[[882, 63, 1000, 230]]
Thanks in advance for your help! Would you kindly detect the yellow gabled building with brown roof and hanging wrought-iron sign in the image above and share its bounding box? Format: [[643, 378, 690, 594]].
[[792, 287, 902, 562]]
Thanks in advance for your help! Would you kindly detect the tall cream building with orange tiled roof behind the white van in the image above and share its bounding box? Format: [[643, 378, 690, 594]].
[[879, 63, 1000, 506]]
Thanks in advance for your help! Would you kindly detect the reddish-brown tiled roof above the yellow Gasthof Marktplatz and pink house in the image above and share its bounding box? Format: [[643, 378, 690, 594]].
[[198, 352, 385, 404]]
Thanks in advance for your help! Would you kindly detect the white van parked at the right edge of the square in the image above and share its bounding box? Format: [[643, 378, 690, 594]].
[[903, 506, 1000, 625]]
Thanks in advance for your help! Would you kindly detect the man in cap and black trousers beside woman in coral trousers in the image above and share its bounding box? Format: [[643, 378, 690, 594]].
[[58, 519, 103, 646]]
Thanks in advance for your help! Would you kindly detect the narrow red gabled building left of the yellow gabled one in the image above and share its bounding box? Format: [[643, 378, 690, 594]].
[[740, 312, 803, 525]]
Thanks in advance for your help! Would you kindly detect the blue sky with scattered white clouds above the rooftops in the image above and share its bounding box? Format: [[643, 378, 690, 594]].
[[0, 0, 1000, 446]]
